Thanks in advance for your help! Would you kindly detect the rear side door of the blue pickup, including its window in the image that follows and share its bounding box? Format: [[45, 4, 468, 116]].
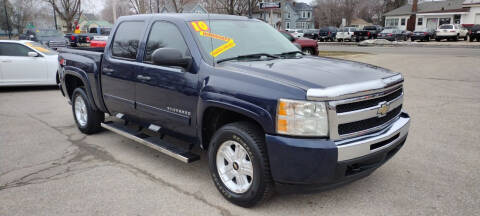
[[101, 21, 145, 117]]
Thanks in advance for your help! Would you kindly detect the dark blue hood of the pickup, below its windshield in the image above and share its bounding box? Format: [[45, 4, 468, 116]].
[[218, 56, 397, 90]]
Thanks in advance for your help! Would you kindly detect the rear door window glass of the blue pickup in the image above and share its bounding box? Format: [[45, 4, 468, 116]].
[[112, 22, 144, 60]]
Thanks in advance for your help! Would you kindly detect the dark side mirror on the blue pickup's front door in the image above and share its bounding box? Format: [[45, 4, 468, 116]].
[[152, 48, 192, 70]]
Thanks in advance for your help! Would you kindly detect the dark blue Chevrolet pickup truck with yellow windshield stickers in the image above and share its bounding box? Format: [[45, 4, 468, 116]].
[[59, 14, 410, 207]]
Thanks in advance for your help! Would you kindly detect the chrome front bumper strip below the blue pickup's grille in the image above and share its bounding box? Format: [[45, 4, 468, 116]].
[[335, 113, 410, 161]]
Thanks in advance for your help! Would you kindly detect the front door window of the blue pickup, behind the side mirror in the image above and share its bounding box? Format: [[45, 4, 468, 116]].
[[144, 22, 190, 62]]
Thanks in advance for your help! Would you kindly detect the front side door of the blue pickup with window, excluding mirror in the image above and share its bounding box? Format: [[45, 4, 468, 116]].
[[136, 21, 198, 138]]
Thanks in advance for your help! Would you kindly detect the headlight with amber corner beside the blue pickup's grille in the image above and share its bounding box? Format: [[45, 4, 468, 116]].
[[277, 99, 328, 136]]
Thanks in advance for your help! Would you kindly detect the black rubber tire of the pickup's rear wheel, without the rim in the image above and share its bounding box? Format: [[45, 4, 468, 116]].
[[72, 88, 105, 134]]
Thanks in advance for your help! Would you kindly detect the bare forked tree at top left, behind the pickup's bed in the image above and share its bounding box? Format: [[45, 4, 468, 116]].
[[44, 0, 82, 32]]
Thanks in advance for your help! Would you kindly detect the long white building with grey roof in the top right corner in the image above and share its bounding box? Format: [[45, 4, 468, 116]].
[[385, 0, 480, 30]]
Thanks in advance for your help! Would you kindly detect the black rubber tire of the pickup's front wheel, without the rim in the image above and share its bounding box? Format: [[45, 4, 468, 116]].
[[208, 122, 274, 207]]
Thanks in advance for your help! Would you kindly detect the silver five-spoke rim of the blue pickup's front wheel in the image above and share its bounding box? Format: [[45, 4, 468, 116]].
[[217, 140, 253, 193]]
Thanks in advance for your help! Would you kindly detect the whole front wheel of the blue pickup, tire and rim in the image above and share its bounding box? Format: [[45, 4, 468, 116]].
[[208, 122, 273, 207]]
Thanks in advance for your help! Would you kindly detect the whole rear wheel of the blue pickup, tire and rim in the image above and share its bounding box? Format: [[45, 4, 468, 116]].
[[72, 88, 105, 134]]
